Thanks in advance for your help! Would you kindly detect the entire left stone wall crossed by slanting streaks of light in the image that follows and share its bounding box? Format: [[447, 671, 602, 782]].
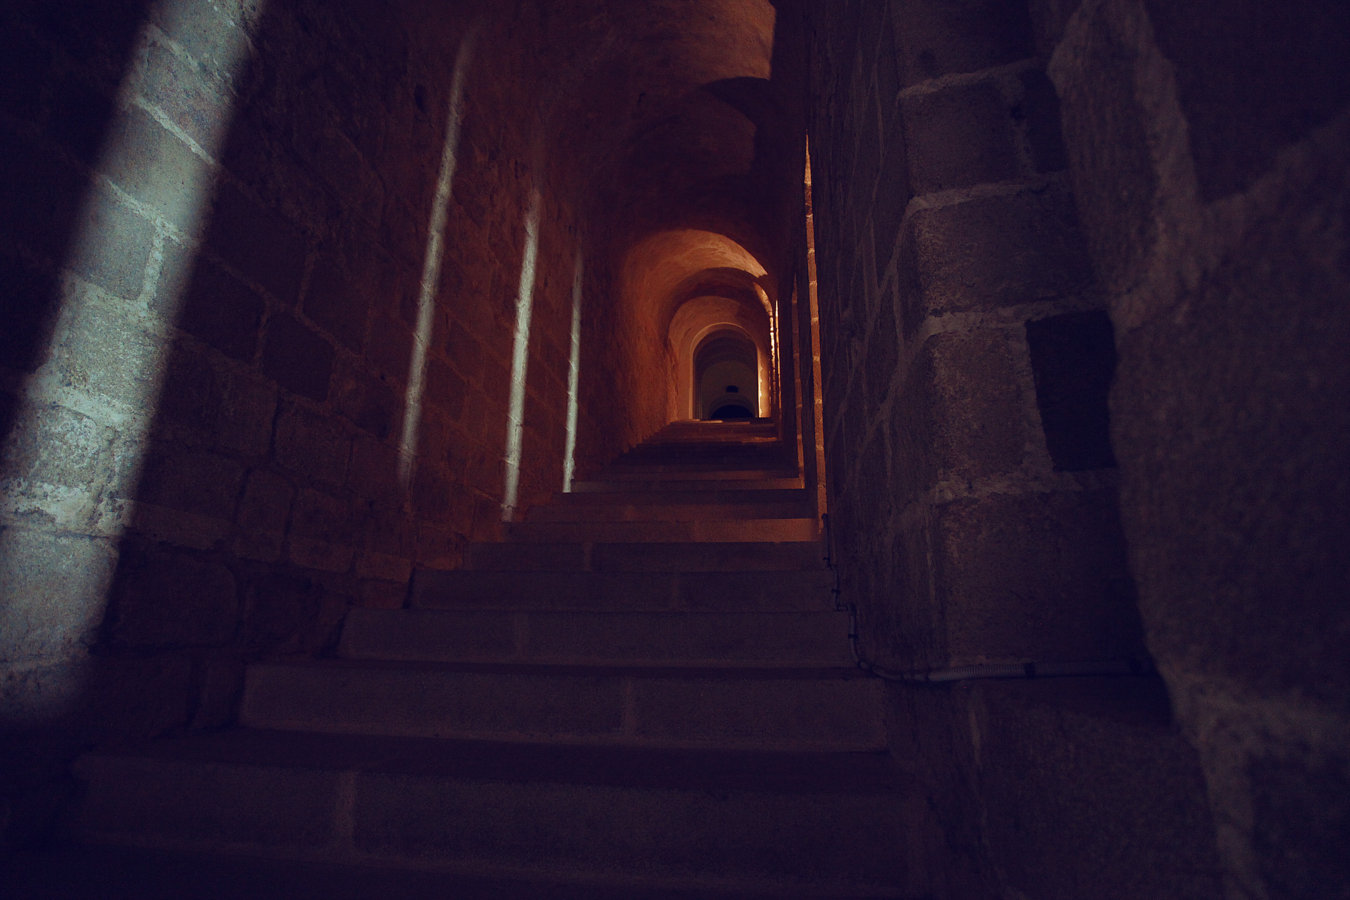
[[0, 0, 608, 734]]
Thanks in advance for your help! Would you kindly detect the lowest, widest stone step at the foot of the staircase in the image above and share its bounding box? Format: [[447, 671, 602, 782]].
[[73, 730, 919, 897]]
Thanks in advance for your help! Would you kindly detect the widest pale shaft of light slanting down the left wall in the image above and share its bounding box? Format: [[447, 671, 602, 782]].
[[0, 0, 262, 721]]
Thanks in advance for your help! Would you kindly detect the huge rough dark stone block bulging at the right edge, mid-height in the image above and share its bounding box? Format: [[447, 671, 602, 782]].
[[1111, 151, 1350, 708]]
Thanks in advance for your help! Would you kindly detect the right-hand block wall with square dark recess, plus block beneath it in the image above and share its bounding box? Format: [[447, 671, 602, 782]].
[[806, 0, 1236, 899]]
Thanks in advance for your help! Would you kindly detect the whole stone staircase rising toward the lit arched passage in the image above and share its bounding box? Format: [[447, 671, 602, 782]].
[[29, 422, 922, 899]]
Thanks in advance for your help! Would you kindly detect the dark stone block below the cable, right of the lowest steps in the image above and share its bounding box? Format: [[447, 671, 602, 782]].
[[968, 677, 1225, 900]]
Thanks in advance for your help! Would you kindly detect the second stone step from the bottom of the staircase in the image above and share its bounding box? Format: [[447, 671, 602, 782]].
[[239, 660, 884, 750]]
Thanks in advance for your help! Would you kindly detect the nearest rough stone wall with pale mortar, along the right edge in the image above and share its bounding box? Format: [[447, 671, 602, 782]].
[[1033, 0, 1350, 897]]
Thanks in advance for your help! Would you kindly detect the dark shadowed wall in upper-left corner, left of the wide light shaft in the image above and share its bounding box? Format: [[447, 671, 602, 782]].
[[0, 0, 149, 441]]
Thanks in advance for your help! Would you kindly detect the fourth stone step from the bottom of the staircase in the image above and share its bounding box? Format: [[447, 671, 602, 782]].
[[410, 569, 834, 613]]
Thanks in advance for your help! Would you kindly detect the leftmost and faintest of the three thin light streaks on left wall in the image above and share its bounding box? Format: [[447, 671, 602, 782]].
[[398, 28, 478, 488]]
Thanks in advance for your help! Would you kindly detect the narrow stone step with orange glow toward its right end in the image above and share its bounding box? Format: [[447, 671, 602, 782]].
[[508, 515, 821, 544]]
